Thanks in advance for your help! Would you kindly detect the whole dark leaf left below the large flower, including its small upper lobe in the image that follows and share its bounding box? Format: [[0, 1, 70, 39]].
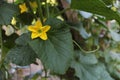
[[5, 33, 37, 66]]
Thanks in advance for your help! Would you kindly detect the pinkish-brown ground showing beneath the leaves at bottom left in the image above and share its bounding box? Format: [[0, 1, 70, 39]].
[[9, 59, 60, 80]]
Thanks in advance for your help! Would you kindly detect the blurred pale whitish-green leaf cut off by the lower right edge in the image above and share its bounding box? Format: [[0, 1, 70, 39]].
[[101, 49, 120, 80]]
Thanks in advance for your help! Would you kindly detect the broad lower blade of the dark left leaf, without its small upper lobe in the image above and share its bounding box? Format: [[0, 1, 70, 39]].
[[5, 46, 37, 66]]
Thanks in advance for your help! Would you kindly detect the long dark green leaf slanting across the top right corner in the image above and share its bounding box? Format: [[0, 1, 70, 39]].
[[71, 0, 120, 24]]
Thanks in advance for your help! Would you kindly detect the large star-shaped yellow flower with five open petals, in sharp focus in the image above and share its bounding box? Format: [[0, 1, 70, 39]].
[[28, 20, 50, 40]]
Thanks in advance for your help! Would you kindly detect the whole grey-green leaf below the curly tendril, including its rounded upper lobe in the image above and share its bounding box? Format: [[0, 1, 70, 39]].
[[71, 51, 113, 80]]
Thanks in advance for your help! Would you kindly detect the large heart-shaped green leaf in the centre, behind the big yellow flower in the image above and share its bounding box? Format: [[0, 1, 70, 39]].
[[29, 19, 73, 74]]
